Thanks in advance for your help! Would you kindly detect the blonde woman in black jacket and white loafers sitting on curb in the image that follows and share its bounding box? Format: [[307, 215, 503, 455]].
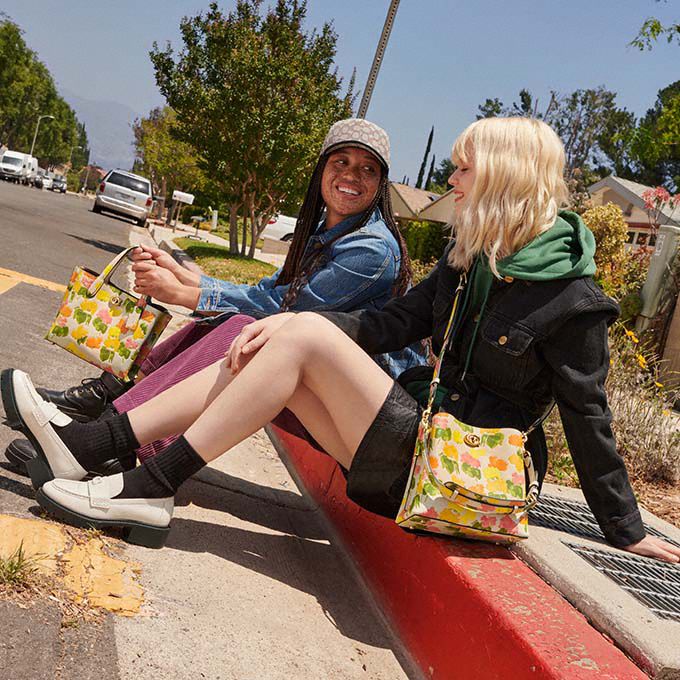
[[11, 118, 680, 562]]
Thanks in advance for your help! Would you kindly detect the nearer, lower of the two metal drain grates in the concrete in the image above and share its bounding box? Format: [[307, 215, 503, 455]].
[[565, 542, 680, 623]]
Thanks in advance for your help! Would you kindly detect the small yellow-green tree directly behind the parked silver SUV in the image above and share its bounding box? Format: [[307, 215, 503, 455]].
[[132, 106, 206, 215]]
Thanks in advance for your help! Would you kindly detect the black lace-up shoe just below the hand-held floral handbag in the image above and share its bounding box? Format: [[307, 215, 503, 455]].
[[37, 371, 134, 423]]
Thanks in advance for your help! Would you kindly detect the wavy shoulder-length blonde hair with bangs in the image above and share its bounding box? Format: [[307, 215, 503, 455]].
[[449, 117, 569, 276]]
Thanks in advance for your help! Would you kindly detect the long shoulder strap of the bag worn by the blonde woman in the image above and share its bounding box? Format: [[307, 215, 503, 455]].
[[420, 272, 540, 510]]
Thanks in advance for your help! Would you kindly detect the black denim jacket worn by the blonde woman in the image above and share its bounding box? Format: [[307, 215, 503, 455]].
[[322, 250, 645, 547]]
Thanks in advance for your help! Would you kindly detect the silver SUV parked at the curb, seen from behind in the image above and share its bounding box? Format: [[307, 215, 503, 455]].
[[92, 170, 153, 227]]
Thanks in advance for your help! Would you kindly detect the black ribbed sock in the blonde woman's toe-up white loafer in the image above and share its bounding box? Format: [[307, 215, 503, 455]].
[[54, 413, 139, 470]]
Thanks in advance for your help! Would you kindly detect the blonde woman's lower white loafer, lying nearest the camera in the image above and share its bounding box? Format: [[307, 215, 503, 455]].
[[36, 473, 175, 548]]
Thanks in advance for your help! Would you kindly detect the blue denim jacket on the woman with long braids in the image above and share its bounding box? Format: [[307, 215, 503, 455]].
[[196, 210, 425, 377]]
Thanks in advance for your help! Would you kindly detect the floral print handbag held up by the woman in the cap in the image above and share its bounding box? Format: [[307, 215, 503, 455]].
[[45, 246, 172, 380]]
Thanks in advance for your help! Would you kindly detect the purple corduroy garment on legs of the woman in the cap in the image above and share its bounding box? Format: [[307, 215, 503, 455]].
[[113, 314, 255, 461]]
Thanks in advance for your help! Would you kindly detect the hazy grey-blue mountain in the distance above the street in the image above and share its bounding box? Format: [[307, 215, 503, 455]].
[[61, 89, 141, 170]]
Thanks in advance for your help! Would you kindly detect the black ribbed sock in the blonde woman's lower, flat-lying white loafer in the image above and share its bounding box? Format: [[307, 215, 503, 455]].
[[116, 436, 206, 498]]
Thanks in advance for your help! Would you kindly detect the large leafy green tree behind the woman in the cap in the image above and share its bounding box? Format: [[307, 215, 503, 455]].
[[150, 0, 353, 257]]
